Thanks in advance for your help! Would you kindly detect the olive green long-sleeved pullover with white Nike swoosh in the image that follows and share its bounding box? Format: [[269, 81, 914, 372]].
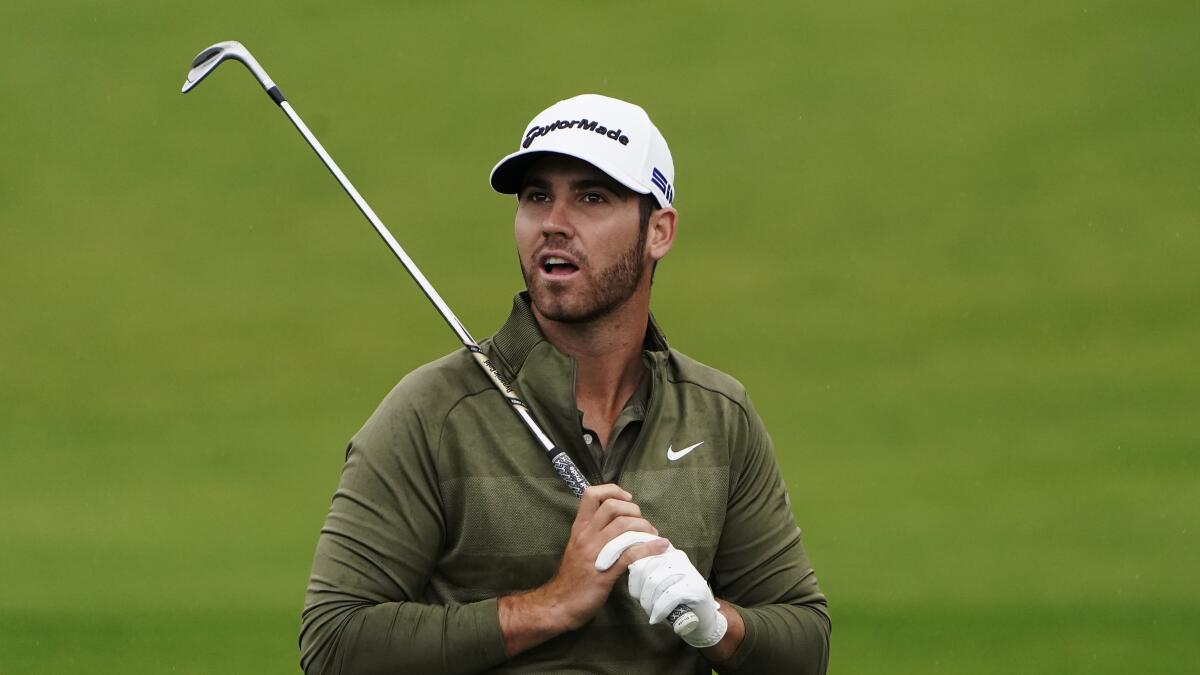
[[300, 293, 830, 674]]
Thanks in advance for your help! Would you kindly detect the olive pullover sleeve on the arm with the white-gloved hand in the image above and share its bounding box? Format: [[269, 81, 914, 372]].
[[712, 401, 832, 674]]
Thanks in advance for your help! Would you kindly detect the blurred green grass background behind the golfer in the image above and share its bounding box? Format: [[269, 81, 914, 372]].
[[0, 0, 1200, 675]]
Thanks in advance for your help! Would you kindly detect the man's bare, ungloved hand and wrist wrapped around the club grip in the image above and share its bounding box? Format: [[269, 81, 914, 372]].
[[499, 484, 670, 656]]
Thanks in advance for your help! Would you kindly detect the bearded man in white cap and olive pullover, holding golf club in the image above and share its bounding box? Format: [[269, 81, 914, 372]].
[[300, 95, 829, 674]]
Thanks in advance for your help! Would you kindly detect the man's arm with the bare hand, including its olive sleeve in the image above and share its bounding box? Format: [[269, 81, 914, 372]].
[[300, 381, 660, 673]]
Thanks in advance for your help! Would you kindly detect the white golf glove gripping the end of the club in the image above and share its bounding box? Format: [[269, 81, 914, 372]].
[[629, 546, 728, 647]]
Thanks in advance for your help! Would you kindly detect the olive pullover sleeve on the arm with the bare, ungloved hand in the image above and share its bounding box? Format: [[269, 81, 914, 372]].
[[300, 383, 505, 674]]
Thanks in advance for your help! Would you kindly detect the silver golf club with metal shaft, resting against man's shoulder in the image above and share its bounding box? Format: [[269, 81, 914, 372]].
[[182, 41, 700, 635]]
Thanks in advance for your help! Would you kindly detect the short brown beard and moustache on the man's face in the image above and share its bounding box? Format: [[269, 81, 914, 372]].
[[521, 227, 648, 323]]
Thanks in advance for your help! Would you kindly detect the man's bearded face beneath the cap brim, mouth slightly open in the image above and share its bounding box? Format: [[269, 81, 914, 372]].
[[516, 155, 647, 323]]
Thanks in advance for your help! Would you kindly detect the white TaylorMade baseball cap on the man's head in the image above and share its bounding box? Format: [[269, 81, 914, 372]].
[[492, 94, 674, 207]]
